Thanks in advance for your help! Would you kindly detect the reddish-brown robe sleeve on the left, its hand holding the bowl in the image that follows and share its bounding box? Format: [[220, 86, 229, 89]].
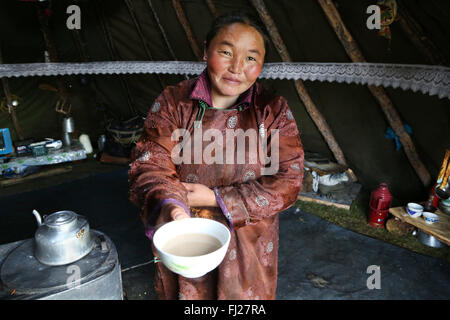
[[128, 89, 189, 238]]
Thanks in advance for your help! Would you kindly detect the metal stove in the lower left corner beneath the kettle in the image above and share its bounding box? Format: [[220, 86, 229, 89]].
[[0, 230, 123, 300]]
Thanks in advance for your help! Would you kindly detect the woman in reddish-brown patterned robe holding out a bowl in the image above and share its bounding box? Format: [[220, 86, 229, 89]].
[[129, 13, 303, 299]]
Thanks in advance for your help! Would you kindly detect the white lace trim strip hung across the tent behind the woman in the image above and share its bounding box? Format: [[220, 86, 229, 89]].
[[0, 61, 450, 99]]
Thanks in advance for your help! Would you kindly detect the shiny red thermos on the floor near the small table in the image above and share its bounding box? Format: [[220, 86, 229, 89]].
[[368, 183, 392, 228]]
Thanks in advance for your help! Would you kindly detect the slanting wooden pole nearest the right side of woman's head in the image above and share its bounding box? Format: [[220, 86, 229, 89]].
[[250, 0, 356, 172]]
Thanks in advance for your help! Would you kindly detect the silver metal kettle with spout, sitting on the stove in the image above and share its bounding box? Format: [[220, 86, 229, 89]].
[[33, 210, 94, 266]]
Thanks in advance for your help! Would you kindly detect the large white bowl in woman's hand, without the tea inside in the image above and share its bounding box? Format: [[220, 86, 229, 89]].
[[153, 218, 231, 278]]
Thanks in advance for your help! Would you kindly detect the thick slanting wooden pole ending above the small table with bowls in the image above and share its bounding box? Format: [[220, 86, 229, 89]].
[[318, 0, 431, 187]]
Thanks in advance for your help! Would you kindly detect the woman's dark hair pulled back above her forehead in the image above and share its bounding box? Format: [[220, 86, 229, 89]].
[[206, 11, 270, 53]]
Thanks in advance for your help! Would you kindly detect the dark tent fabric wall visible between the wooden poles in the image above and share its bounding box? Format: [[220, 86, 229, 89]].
[[0, 0, 450, 199]]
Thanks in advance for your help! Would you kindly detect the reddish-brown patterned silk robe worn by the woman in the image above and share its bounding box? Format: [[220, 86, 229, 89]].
[[129, 70, 304, 299]]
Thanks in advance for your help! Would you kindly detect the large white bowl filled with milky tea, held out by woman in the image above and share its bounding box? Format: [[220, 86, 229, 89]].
[[153, 218, 231, 278]]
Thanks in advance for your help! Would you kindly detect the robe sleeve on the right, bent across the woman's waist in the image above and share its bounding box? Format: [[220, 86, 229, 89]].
[[214, 97, 304, 229]]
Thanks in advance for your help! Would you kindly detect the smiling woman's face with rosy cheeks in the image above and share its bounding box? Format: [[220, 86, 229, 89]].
[[203, 23, 266, 104]]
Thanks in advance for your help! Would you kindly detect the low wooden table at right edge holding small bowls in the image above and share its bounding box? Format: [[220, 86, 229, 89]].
[[389, 207, 450, 246]]
